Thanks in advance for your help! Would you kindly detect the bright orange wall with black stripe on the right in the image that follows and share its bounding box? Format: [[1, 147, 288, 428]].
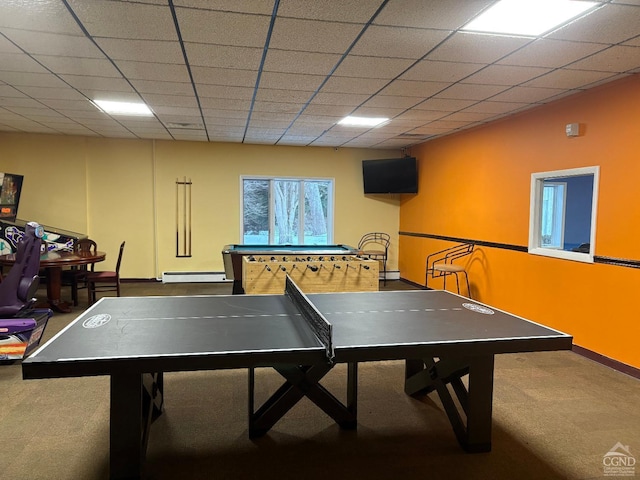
[[399, 75, 640, 368]]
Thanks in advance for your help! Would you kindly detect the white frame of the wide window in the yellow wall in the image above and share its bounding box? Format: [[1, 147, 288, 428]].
[[239, 175, 336, 245]]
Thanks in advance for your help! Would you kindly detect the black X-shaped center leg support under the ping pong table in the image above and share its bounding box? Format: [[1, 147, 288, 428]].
[[249, 363, 358, 438]]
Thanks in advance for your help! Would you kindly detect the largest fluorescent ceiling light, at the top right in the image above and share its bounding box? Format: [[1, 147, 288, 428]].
[[462, 0, 602, 36]]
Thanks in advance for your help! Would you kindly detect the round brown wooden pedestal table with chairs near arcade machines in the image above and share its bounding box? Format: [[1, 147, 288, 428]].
[[0, 250, 107, 313]]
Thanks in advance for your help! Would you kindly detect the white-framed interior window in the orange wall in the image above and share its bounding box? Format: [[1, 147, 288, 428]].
[[529, 167, 599, 262]]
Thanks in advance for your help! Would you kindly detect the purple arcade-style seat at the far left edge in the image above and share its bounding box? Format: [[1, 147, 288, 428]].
[[0, 222, 43, 318]]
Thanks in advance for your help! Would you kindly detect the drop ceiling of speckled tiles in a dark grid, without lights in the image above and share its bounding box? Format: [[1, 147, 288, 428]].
[[0, 0, 640, 149]]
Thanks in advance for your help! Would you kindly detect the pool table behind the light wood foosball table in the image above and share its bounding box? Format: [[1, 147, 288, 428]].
[[222, 244, 358, 294]]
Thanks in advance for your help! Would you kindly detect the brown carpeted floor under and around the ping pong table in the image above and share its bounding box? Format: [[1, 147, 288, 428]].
[[0, 281, 640, 480]]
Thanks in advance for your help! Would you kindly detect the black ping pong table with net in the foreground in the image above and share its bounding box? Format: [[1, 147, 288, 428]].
[[22, 280, 572, 479]]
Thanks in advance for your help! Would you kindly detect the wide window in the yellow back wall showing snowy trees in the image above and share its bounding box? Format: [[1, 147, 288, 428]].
[[241, 177, 333, 245]]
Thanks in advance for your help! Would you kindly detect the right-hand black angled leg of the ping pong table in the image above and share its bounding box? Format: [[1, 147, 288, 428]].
[[405, 355, 494, 453]]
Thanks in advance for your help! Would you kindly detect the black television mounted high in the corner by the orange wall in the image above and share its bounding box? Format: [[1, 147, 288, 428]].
[[362, 157, 418, 193]]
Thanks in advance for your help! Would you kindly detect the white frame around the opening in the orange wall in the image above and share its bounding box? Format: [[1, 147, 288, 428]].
[[528, 166, 600, 263]]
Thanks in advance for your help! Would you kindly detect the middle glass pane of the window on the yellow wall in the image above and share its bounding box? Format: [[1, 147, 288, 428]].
[[273, 180, 300, 244]]
